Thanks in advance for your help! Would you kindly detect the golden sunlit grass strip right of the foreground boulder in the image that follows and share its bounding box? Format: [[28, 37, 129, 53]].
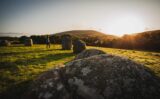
[[88, 47, 160, 76]]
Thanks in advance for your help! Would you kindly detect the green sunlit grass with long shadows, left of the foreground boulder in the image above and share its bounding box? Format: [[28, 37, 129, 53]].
[[0, 45, 74, 98]]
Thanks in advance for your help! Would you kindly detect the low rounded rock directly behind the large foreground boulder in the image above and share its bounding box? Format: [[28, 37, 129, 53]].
[[75, 49, 106, 60]]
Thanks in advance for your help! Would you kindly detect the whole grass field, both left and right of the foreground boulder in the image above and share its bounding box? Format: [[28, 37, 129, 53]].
[[0, 45, 160, 99]]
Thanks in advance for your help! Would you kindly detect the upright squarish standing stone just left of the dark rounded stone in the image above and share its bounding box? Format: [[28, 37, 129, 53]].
[[62, 35, 72, 50]]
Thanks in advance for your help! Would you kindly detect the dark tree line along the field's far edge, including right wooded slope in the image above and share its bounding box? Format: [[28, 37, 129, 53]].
[[0, 30, 160, 51]]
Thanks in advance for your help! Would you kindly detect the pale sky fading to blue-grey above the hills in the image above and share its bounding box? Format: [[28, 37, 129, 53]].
[[0, 0, 160, 36]]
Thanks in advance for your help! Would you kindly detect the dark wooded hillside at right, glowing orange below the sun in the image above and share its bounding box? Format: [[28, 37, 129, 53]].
[[114, 30, 160, 51]]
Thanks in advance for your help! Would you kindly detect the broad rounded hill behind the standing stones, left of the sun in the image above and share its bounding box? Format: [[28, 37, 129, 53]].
[[53, 30, 118, 47]]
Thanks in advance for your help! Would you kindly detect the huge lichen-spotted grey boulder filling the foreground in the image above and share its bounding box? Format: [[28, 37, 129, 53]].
[[25, 54, 160, 99]]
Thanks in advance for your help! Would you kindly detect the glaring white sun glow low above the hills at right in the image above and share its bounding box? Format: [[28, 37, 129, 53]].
[[107, 15, 145, 36]]
